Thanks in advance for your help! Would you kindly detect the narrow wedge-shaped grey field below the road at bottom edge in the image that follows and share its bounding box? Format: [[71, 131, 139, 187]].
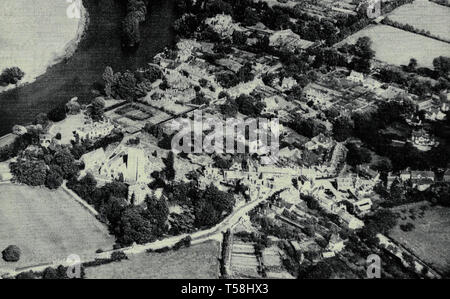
[[86, 241, 219, 279]]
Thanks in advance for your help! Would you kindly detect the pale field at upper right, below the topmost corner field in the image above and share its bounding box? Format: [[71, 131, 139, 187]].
[[340, 25, 450, 68]]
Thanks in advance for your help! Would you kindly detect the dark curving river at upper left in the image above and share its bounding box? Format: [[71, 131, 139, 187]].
[[0, 0, 175, 136]]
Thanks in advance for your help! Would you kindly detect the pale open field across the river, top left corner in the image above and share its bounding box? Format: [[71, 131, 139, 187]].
[[0, 0, 88, 92]]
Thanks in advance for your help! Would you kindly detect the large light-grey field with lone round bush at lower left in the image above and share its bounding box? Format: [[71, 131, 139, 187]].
[[0, 184, 114, 269]]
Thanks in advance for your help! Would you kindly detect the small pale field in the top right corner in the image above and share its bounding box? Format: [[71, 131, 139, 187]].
[[389, 0, 450, 40]]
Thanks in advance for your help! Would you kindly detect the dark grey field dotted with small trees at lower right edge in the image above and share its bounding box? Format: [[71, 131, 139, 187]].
[[389, 206, 450, 271]]
